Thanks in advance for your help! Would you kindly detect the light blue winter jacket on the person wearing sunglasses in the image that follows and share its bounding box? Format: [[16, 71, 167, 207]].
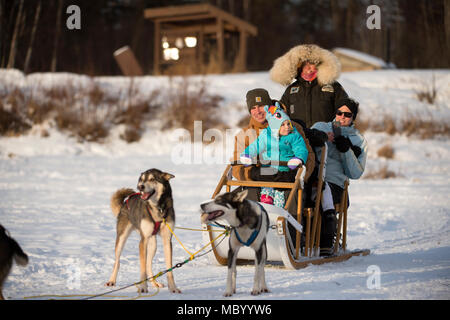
[[311, 122, 367, 188]]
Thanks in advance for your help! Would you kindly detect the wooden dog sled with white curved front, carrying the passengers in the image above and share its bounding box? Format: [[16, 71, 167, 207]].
[[202, 145, 370, 269]]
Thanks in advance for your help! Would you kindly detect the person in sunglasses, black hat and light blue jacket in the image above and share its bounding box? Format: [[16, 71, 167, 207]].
[[311, 98, 367, 255]]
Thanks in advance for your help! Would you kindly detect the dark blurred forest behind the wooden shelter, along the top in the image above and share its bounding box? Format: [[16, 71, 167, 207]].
[[0, 0, 450, 76]]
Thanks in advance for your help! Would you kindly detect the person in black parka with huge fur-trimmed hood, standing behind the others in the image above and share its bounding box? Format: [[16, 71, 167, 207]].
[[270, 44, 348, 128]]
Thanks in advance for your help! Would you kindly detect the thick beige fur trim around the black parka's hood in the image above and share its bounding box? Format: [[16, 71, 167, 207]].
[[270, 44, 341, 86]]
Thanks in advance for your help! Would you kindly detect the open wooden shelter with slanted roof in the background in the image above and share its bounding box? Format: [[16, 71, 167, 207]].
[[144, 3, 258, 74]]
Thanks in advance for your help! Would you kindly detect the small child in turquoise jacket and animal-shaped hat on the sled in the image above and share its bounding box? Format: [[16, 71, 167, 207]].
[[240, 102, 308, 207]]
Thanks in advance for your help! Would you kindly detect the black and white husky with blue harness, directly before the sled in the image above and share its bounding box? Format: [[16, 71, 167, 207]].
[[200, 189, 269, 297]]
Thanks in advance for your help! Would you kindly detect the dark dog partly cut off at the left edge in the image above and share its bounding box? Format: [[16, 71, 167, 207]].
[[0, 224, 28, 300]]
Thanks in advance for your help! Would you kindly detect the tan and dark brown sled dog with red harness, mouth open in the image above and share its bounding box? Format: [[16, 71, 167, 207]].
[[105, 169, 181, 293]]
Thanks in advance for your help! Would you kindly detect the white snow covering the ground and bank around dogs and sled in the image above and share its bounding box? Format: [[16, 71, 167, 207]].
[[0, 70, 450, 300]]
